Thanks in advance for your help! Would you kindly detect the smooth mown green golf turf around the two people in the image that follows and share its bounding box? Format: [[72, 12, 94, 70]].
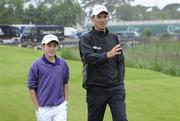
[[0, 46, 180, 121]]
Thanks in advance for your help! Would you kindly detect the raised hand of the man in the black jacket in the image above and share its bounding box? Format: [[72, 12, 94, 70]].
[[107, 44, 122, 58]]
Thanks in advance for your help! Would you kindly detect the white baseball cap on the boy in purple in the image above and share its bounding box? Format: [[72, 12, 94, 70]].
[[41, 34, 59, 45]]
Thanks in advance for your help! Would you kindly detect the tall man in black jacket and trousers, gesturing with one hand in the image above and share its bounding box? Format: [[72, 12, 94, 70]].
[[79, 5, 127, 121]]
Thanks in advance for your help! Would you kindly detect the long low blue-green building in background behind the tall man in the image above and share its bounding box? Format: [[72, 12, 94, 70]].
[[86, 20, 180, 35]]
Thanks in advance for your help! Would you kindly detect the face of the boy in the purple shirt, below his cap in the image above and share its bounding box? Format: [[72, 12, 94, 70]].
[[42, 41, 58, 58]]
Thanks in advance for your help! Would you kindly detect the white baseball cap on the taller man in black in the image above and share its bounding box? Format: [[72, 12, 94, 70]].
[[91, 5, 108, 16]]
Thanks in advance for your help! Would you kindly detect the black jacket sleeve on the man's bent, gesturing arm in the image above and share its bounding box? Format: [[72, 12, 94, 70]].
[[79, 36, 108, 64]]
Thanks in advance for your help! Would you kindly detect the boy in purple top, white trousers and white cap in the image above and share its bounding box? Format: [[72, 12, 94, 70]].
[[28, 34, 69, 121]]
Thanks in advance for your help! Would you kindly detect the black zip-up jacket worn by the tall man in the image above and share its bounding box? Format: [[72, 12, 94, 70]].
[[79, 27, 125, 88]]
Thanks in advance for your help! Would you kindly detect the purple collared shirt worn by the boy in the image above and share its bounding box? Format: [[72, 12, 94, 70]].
[[28, 55, 69, 107]]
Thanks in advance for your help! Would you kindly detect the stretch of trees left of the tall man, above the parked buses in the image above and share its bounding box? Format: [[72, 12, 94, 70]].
[[0, 0, 83, 26]]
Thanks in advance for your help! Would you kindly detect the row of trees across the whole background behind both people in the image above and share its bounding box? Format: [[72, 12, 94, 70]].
[[0, 0, 180, 26]]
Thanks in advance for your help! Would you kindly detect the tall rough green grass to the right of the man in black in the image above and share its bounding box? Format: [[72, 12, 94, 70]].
[[125, 40, 180, 76]]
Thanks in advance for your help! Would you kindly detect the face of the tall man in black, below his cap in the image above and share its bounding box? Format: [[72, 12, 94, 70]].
[[92, 12, 109, 31]]
